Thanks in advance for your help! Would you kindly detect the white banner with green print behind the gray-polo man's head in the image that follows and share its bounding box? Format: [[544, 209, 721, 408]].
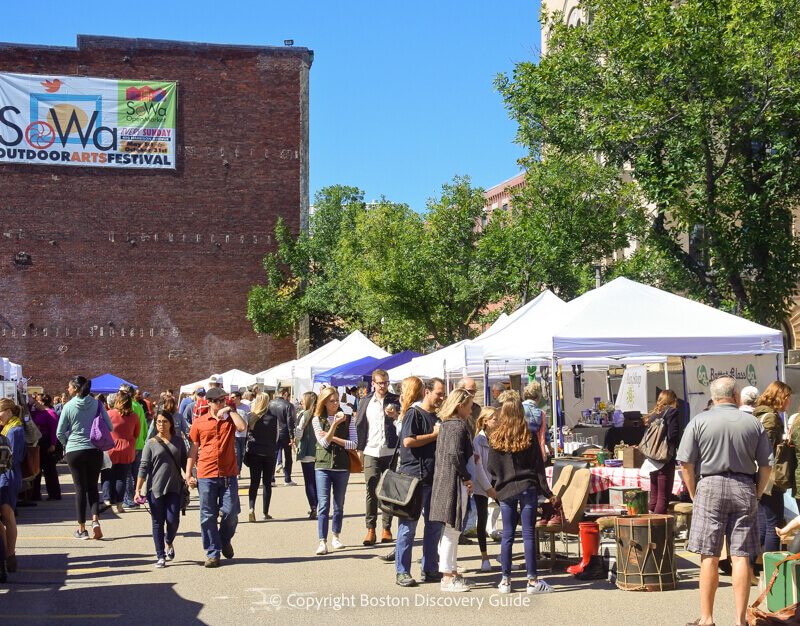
[[684, 354, 778, 417]]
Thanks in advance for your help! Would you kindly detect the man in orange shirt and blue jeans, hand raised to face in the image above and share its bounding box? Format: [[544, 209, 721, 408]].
[[186, 388, 247, 567]]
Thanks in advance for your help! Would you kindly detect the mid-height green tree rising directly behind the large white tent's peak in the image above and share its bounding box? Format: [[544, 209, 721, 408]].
[[482, 153, 646, 305]]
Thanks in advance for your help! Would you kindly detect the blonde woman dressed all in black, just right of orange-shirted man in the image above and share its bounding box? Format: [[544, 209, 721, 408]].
[[243, 393, 278, 522]]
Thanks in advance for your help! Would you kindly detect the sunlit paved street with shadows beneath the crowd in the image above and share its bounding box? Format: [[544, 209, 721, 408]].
[[0, 465, 736, 626]]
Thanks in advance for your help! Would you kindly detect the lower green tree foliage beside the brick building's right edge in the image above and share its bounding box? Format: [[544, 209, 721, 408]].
[[248, 176, 499, 350]]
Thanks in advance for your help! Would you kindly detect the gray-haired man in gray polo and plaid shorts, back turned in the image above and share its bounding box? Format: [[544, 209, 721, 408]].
[[677, 377, 774, 626]]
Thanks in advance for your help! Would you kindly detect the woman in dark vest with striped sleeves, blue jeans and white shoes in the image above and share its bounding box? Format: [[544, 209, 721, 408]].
[[311, 387, 358, 555]]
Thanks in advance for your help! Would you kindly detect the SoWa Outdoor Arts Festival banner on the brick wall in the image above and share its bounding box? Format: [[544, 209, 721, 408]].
[[0, 73, 177, 169]]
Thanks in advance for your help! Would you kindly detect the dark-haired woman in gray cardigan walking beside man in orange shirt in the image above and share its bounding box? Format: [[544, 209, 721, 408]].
[[136, 410, 186, 568]]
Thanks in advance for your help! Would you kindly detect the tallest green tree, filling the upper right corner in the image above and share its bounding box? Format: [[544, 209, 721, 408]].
[[496, 0, 800, 325]]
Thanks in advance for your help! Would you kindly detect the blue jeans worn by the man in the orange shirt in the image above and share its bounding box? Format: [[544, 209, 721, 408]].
[[197, 476, 240, 559]]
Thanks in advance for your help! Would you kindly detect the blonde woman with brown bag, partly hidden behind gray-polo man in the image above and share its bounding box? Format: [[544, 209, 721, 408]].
[[753, 380, 797, 552]]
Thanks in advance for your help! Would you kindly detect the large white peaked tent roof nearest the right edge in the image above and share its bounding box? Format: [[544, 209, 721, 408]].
[[553, 278, 783, 359]]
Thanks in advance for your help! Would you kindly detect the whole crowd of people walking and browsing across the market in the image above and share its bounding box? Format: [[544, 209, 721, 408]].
[[0, 369, 800, 624]]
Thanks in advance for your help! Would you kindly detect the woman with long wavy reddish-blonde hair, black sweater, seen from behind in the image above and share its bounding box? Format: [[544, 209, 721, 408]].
[[488, 400, 559, 594]]
